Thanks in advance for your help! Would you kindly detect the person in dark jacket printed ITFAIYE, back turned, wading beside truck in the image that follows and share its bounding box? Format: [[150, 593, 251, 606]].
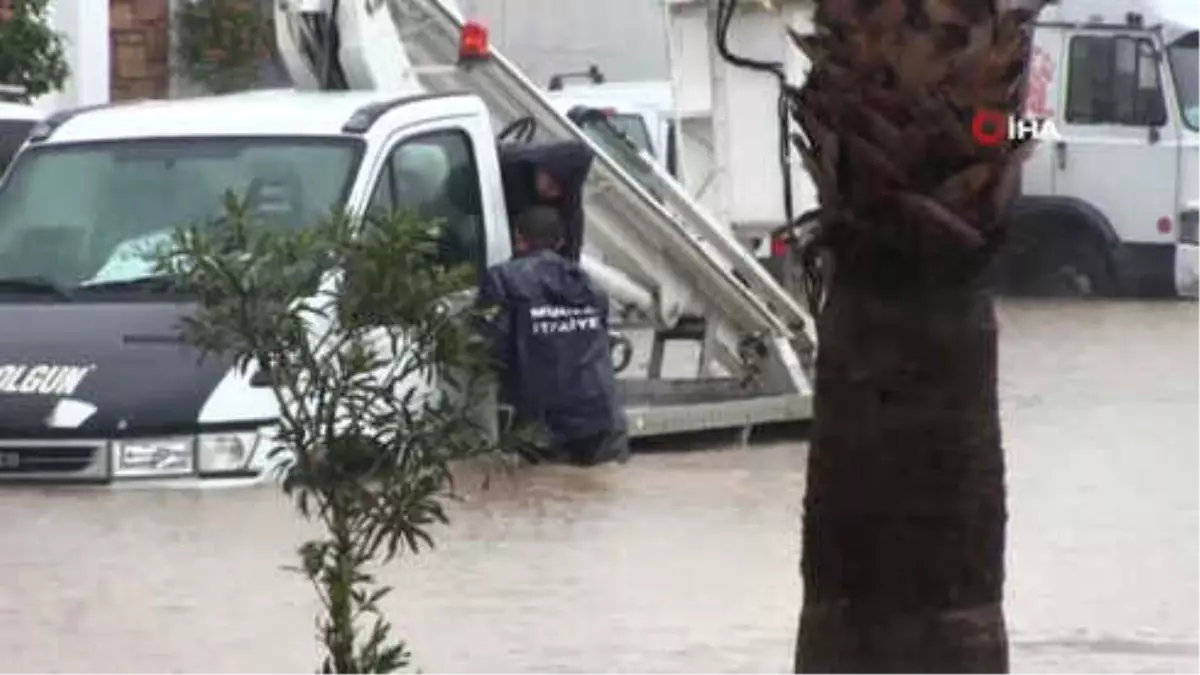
[[479, 205, 629, 466]]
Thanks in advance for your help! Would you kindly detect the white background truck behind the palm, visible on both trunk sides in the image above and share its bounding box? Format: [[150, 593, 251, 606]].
[[664, 0, 1200, 297]]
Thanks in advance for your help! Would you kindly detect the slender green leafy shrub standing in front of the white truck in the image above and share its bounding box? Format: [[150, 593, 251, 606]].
[[158, 196, 509, 675]]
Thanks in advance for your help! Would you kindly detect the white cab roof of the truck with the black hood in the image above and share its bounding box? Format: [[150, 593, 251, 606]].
[[35, 89, 486, 144]]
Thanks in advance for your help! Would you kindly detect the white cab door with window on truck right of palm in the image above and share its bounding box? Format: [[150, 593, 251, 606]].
[[1046, 30, 1180, 253]]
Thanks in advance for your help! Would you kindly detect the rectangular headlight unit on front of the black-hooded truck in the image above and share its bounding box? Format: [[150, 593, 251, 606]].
[[113, 432, 258, 478]]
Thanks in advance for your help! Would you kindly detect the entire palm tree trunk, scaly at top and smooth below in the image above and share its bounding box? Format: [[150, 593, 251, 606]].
[[792, 0, 1044, 675]]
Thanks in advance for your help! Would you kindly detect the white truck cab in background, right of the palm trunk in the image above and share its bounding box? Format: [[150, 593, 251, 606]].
[[1001, 0, 1200, 295]]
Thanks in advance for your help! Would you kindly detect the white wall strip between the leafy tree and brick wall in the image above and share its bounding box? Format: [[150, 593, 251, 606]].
[[34, 0, 110, 112]]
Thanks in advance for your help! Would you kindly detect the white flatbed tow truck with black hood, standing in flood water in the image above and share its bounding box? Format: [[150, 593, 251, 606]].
[[0, 0, 814, 485]]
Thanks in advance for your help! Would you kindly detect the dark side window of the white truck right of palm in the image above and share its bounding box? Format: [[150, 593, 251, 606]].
[[1067, 35, 1166, 126]]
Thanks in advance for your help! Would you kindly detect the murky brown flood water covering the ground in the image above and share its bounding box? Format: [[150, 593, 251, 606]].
[[0, 301, 1200, 675]]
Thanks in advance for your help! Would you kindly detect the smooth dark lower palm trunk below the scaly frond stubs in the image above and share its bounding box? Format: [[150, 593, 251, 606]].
[[796, 270, 1008, 675]]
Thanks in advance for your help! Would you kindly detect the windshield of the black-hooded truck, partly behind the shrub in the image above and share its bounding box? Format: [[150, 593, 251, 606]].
[[0, 137, 361, 291]]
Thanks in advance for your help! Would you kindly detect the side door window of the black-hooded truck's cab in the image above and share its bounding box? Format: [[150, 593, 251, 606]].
[[371, 130, 486, 277]]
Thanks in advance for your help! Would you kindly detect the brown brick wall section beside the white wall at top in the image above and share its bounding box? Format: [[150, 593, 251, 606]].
[[108, 0, 170, 101]]
